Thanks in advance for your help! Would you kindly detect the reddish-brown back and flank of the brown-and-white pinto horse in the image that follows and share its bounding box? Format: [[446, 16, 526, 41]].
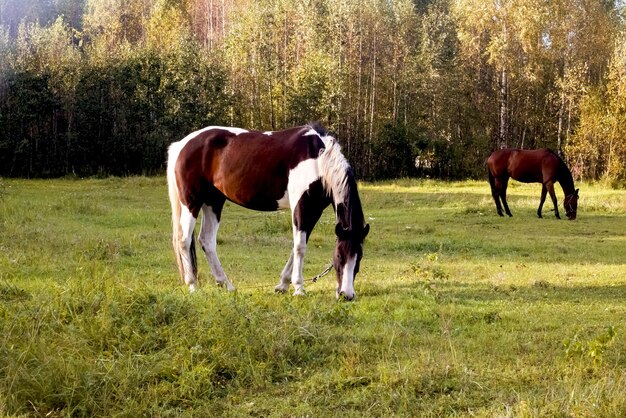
[[175, 127, 324, 210]]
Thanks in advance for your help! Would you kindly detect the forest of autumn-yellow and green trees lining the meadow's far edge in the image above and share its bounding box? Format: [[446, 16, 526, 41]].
[[0, 0, 626, 183]]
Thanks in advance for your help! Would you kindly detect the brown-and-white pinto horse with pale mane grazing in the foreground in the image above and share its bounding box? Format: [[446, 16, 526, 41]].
[[167, 124, 369, 300]]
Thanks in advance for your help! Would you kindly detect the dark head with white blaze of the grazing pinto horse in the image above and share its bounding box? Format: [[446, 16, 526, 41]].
[[333, 223, 370, 300]]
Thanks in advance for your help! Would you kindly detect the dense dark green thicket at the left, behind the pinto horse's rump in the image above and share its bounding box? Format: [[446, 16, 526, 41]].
[[0, 15, 228, 177]]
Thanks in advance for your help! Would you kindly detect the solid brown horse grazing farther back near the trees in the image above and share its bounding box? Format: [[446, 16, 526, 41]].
[[487, 149, 578, 220]]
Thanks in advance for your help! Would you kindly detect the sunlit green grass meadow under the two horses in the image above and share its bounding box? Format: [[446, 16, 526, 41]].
[[0, 178, 626, 417]]
